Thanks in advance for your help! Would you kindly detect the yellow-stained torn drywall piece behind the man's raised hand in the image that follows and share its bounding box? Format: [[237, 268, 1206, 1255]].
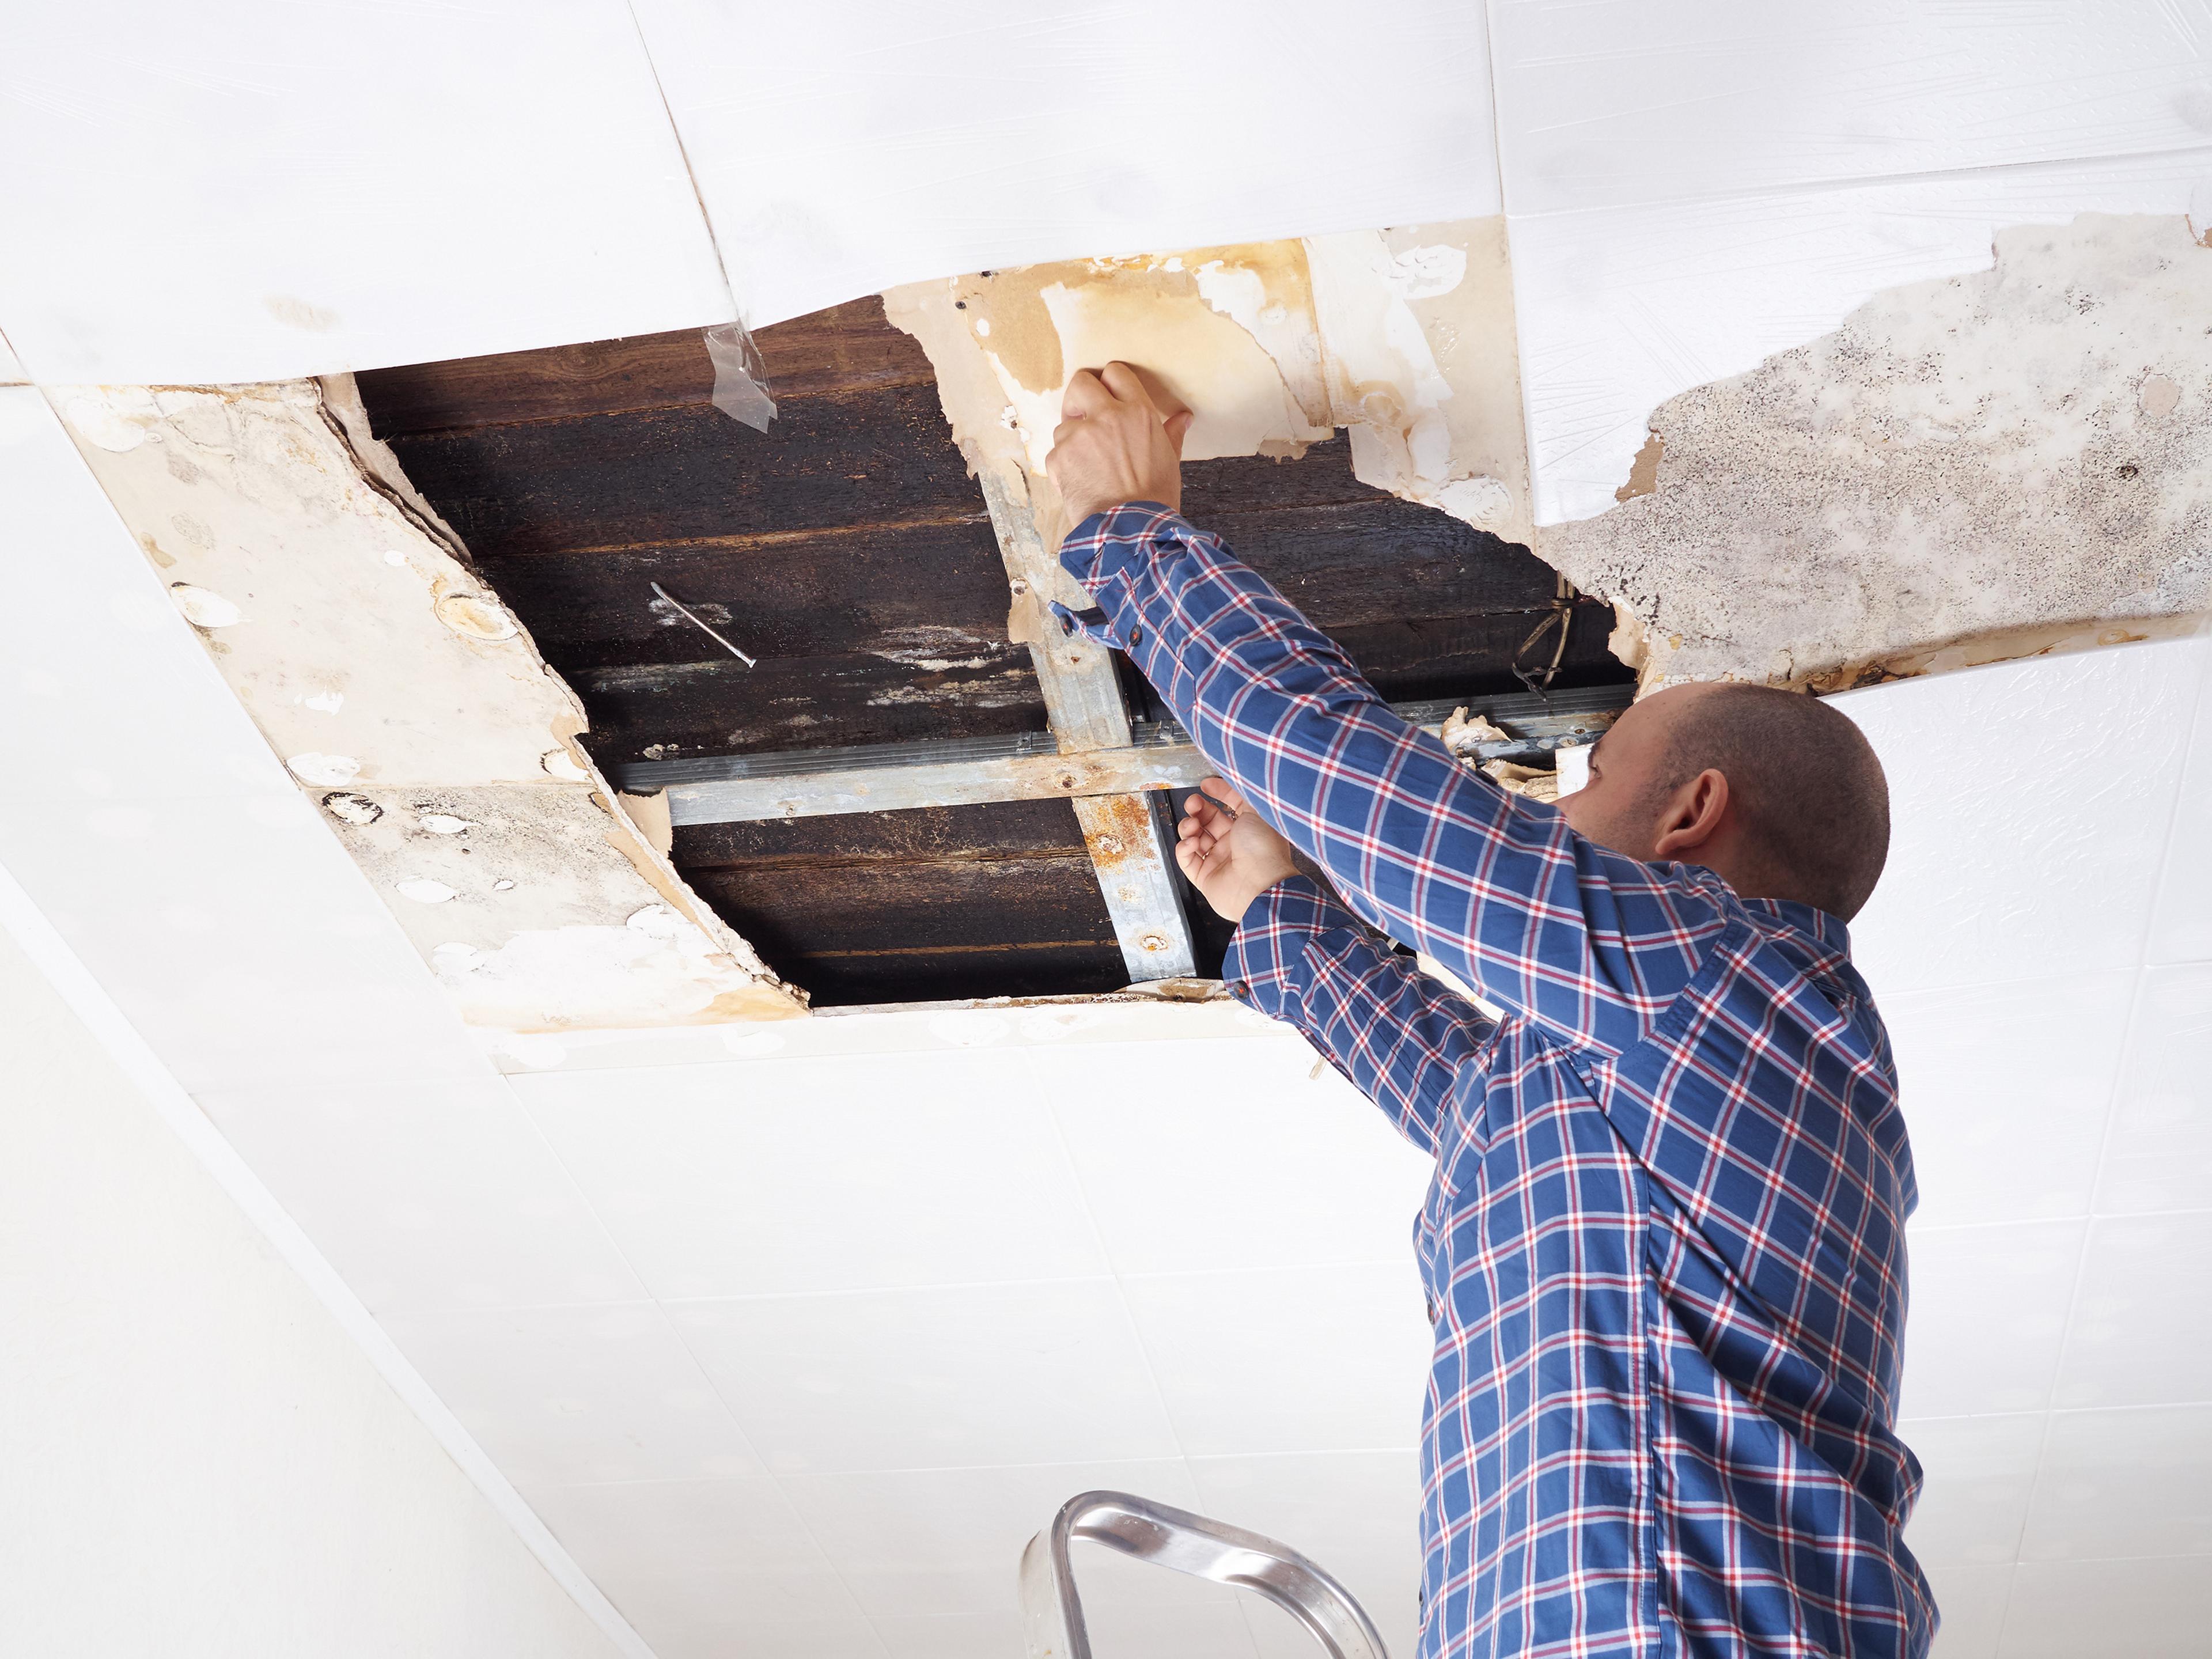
[[885, 219, 1531, 544]]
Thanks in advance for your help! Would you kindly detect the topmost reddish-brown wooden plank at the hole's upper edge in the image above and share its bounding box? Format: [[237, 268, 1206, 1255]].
[[354, 297, 935, 438]]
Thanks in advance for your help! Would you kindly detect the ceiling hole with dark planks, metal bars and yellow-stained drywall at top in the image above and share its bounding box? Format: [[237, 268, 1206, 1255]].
[[358, 221, 1628, 1006]]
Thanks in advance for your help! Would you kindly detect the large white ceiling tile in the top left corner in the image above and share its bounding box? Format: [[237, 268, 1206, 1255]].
[[0, 0, 730, 385]]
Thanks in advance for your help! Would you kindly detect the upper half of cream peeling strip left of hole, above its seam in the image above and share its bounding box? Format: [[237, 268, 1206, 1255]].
[[53, 380, 584, 783]]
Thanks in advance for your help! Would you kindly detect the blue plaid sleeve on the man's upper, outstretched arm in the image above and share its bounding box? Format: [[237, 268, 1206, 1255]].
[[1055, 502, 1728, 1058]]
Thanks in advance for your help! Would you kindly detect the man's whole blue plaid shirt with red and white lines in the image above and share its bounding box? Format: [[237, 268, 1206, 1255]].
[[1059, 502, 1936, 1659]]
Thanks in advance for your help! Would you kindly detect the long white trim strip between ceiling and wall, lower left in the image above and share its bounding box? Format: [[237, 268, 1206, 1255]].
[[0, 865, 657, 1659]]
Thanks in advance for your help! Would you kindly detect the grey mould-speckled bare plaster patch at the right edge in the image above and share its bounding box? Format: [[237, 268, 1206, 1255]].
[[1537, 214, 2212, 688]]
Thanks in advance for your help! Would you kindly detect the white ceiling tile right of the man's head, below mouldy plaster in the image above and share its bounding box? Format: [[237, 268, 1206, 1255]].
[[1832, 639, 2199, 999]]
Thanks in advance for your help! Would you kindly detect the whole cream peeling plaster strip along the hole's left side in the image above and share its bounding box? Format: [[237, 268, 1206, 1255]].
[[53, 380, 805, 1031]]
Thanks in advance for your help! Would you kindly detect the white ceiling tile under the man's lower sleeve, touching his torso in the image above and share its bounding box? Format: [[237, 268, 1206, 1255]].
[[1052, 1033, 1435, 1274]]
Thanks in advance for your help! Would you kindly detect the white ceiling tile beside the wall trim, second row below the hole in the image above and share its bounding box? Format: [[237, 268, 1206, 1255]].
[[380, 1303, 761, 1500]]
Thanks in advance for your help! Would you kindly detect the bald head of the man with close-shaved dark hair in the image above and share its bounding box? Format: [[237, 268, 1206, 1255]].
[[1559, 685, 1889, 920]]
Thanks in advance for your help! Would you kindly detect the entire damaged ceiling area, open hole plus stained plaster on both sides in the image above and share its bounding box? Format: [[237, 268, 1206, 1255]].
[[55, 217, 2212, 1031]]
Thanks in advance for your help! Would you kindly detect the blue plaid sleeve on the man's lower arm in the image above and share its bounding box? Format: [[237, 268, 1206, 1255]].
[[1221, 876, 1498, 1153]]
